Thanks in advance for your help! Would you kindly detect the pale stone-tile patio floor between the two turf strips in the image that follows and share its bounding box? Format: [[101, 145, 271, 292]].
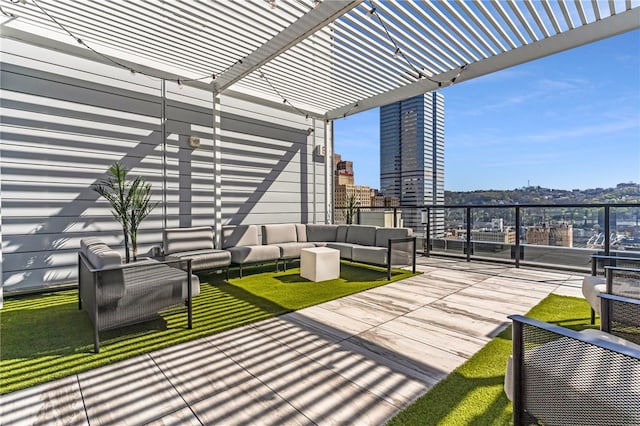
[[0, 258, 583, 425]]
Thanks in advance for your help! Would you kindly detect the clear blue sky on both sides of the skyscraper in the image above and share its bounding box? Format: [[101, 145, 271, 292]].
[[334, 30, 640, 191]]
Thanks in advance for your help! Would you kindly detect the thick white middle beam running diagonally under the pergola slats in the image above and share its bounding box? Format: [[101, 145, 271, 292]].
[[215, 0, 364, 92]]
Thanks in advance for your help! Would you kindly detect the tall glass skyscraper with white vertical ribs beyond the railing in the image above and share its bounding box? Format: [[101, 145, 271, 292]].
[[380, 92, 444, 238]]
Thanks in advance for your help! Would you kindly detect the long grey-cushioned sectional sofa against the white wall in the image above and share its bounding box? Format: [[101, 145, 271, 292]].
[[157, 223, 415, 278]]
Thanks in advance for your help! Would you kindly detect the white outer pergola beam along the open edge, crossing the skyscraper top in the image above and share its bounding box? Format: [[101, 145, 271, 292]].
[[325, 8, 640, 120]]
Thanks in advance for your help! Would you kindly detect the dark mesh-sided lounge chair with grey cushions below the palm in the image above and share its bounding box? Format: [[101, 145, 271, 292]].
[[78, 238, 200, 353]]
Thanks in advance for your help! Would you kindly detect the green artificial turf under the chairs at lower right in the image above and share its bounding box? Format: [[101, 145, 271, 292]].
[[388, 294, 598, 426]]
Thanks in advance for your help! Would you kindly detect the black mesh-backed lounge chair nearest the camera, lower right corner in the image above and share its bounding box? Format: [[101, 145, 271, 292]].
[[505, 315, 640, 426]]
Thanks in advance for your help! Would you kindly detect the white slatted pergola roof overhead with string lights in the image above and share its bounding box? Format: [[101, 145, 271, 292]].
[[5, 0, 640, 120]]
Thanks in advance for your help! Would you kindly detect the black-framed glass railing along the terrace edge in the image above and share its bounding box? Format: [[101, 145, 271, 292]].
[[334, 203, 640, 271]]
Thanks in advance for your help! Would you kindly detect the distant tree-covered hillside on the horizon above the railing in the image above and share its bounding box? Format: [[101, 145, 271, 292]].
[[444, 183, 640, 205]]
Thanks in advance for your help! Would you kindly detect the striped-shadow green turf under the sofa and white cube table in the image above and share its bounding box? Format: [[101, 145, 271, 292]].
[[0, 262, 412, 394]]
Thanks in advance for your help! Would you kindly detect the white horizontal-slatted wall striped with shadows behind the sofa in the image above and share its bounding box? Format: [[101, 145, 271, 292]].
[[0, 38, 325, 292]]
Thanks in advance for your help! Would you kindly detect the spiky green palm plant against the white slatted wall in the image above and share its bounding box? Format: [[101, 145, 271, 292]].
[[93, 162, 158, 263]]
